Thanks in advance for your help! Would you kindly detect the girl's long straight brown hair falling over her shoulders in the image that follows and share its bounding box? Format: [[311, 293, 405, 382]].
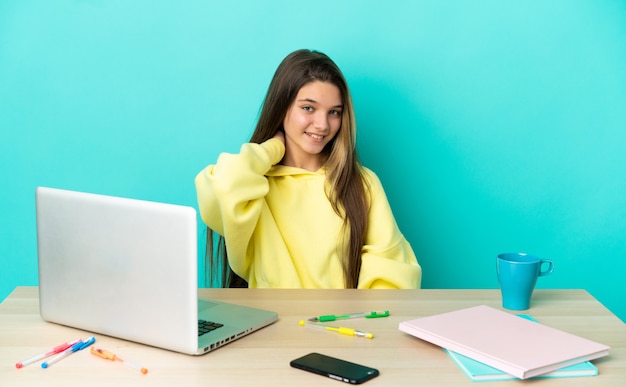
[[206, 50, 369, 288]]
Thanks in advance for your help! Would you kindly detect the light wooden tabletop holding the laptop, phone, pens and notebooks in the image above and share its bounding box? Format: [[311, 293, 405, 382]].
[[0, 287, 626, 387]]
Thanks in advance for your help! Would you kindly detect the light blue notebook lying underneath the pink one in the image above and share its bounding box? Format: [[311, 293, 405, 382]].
[[444, 314, 598, 382]]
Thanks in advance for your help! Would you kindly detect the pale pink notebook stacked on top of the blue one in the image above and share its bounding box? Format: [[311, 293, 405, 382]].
[[399, 305, 609, 379]]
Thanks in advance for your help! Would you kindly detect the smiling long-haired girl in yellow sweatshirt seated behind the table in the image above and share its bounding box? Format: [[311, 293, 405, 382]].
[[195, 50, 421, 288]]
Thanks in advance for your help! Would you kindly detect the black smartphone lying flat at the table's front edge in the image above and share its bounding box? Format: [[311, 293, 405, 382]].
[[289, 352, 380, 384]]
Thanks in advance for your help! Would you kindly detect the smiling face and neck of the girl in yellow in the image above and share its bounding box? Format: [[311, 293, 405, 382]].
[[283, 81, 343, 171]]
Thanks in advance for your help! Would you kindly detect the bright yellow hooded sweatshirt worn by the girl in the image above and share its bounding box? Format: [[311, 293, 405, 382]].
[[195, 139, 422, 289]]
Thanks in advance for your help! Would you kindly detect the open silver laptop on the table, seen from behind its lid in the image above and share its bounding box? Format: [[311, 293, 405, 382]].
[[36, 187, 277, 355]]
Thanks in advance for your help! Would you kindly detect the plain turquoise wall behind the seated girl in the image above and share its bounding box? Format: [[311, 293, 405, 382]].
[[0, 0, 626, 320]]
